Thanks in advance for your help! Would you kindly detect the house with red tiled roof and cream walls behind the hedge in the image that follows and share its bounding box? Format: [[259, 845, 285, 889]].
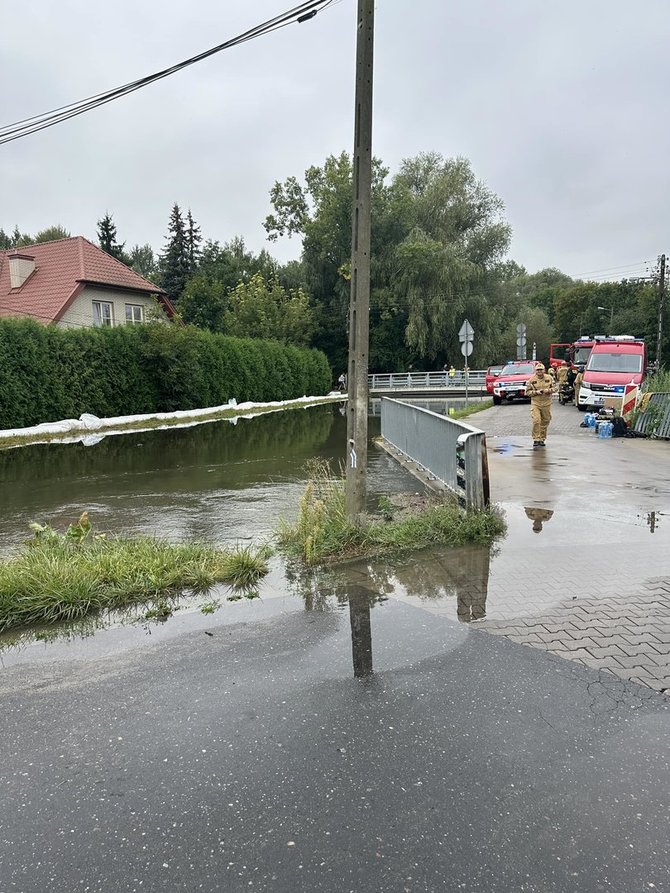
[[0, 236, 175, 328]]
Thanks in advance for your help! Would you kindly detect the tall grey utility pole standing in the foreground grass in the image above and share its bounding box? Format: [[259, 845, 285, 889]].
[[346, 0, 375, 521]]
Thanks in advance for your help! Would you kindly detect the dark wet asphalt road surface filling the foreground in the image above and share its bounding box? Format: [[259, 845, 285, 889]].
[[0, 587, 669, 893]]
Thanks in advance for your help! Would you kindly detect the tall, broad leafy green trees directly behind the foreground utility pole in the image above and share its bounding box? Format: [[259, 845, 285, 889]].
[[265, 153, 510, 369]]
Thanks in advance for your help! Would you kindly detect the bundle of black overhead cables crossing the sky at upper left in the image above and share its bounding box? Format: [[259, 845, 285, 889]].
[[0, 0, 335, 145]]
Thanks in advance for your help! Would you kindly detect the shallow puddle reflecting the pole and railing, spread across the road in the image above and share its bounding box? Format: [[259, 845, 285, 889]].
[[5, 499, 670, 667]]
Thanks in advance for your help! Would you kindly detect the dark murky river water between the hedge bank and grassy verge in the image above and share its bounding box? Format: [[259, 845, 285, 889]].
[[0, 405, 416, 549]]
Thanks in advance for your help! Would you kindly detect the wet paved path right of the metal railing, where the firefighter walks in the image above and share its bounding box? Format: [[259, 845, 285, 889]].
[[462, 404, 670, 693]]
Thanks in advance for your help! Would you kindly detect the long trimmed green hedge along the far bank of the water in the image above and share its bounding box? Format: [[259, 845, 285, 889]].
[[0, 319, 332, 429]]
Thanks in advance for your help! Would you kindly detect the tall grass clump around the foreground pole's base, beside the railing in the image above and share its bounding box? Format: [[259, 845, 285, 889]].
[[277, 463, 505, 565]]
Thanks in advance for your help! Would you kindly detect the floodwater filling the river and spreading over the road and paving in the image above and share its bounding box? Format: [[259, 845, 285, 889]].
[[0, 400, 670, 672]]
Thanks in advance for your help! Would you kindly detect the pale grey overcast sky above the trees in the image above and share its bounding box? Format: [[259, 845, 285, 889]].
[[0, 0, 670, 275]]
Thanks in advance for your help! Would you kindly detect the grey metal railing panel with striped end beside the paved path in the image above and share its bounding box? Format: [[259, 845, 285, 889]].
[[381, 397, 489, 510]]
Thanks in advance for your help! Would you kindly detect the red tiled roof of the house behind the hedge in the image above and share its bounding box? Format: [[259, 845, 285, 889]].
[[0, 236, 174, 323]]
